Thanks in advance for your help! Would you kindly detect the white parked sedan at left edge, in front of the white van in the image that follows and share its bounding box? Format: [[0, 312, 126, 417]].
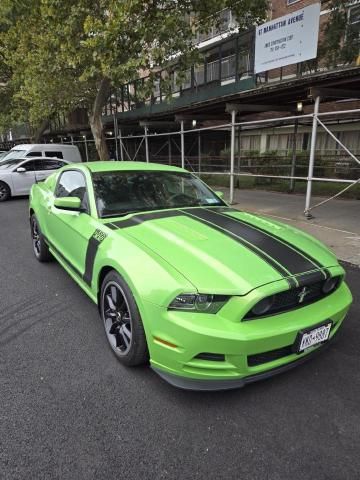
[[0, 157, 71, 202]]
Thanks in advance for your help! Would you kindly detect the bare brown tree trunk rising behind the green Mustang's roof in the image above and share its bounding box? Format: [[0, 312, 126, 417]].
[[89, 78, 110, 160]]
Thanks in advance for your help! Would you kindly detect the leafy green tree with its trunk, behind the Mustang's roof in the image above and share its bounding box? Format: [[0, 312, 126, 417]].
[[0, 0, 268, 159]]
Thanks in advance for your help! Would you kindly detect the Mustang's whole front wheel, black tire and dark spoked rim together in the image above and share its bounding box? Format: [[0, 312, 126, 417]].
[[100, 271, 149, 366]]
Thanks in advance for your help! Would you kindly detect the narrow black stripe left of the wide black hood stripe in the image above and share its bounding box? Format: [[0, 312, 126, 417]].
[[183, 208, 298, 288]]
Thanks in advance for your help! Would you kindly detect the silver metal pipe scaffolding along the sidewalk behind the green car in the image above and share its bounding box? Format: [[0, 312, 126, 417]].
[[64, 89, 360, 218]]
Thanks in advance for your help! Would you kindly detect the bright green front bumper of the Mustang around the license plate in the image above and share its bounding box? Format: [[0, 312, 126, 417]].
[[144, 282, 352, 390]]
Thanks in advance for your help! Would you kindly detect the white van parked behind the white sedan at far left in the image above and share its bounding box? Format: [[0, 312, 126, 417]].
[[0, 143, 81, 163]]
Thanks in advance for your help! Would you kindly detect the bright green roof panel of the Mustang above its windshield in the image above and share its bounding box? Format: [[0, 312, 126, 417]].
[[72, 160, 186, 173]]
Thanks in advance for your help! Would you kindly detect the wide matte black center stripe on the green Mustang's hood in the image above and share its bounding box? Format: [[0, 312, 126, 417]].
[[186, 208, 324, 280]]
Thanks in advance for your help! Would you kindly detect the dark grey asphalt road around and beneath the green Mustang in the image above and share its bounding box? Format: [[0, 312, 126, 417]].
[[0, 199, 360, 480]]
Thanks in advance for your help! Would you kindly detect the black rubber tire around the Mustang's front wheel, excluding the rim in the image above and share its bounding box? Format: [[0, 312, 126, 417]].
[[100, 270, 149, 367]]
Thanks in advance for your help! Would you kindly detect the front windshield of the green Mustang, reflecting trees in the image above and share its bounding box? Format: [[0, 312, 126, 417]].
[[93, 171, 225, 218]]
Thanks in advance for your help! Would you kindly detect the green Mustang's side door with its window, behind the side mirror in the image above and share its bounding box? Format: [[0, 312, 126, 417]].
[[46, 170, 95, 277]]
